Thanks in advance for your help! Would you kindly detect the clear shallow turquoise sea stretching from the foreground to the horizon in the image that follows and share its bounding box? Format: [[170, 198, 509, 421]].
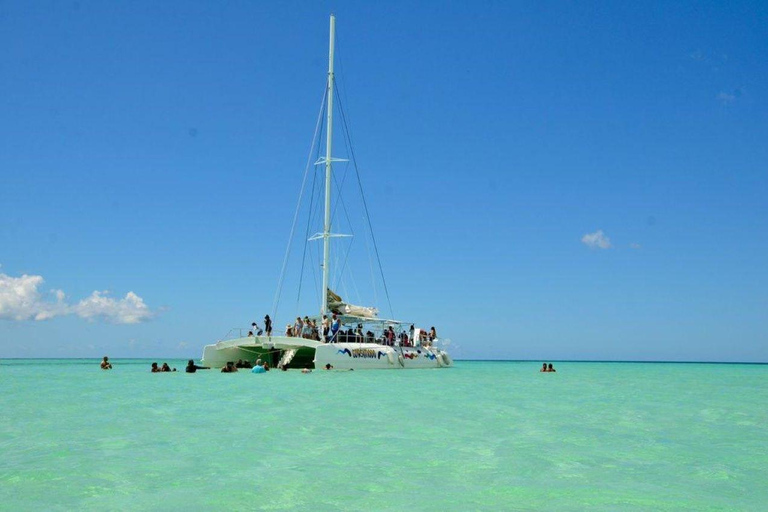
[[0, 359, 768, 511]]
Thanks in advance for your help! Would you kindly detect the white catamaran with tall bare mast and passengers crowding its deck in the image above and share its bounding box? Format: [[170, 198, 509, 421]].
[[203, 15, 453, 370]]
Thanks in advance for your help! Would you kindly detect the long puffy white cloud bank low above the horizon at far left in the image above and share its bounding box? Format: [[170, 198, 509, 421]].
[[0, 273, 155, 324]]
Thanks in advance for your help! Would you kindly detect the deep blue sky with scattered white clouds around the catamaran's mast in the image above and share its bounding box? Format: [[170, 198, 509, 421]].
[[0, 1, 768, 361]]
